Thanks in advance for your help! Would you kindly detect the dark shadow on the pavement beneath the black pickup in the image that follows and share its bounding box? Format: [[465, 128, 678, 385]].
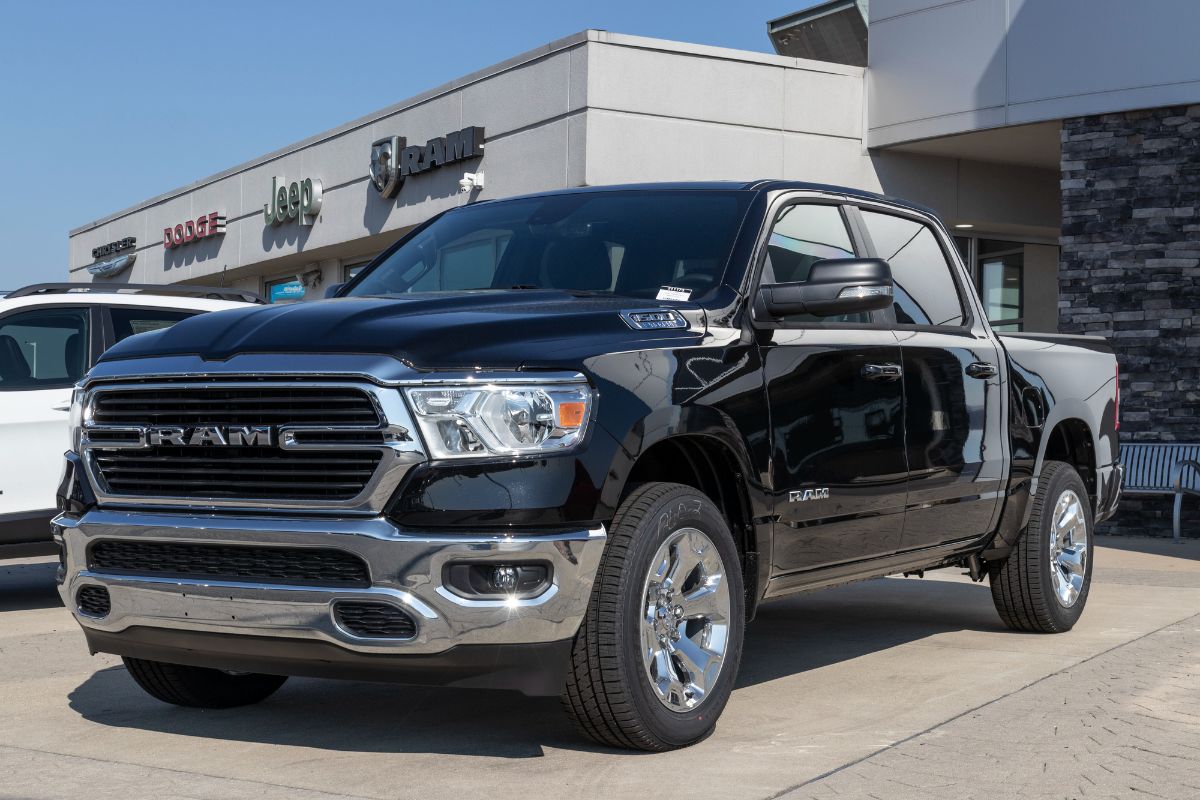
[[70, 579, 1003, 758]]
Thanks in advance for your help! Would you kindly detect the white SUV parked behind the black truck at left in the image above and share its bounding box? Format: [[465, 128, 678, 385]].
[[0, 283, 263, 558]]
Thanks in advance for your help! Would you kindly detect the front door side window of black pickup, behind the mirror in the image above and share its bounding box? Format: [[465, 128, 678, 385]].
[[761, 204, 871, 323]]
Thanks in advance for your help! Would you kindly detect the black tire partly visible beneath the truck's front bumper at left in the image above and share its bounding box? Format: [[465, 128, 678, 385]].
[[121, 657, 287, 709]]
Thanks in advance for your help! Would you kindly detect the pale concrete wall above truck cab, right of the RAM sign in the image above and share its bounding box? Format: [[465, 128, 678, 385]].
[[586, 34, 1060, 236]]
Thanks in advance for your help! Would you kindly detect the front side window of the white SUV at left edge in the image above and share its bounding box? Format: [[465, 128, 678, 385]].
[[0, 308, 88, 391]]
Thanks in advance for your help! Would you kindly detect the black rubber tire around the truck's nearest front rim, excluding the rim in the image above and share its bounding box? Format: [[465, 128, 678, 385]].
[[563, 483, 745, 752]]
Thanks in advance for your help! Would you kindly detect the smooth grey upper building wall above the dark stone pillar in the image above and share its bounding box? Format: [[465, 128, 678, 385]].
[[868, 0, 1200, 146]]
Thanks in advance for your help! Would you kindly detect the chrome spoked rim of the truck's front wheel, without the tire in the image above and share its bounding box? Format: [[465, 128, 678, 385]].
[[641, 528, 730, 712]]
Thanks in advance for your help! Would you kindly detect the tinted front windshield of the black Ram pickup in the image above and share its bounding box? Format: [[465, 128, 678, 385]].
[[347, 191, 750, 299]]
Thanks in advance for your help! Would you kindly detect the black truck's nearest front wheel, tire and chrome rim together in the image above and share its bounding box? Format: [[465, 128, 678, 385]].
[[563, 483, 745, 751]]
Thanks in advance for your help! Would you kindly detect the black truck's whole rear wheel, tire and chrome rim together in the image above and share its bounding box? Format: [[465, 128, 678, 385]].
[[989, 461, 1092, 633]]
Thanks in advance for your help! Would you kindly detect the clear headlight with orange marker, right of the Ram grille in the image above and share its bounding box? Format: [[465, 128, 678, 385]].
[[406, 384, 592, 458]]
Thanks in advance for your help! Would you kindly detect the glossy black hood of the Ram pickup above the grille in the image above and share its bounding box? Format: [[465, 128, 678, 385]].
[[102, 290, 698, 368]]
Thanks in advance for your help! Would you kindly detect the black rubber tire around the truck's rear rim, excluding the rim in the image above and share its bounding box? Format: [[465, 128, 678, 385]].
[[989, 461, 1093, 633]]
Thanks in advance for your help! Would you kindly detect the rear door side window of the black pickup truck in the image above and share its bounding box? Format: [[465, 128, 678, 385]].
[[860, 209, 966, 327]]
